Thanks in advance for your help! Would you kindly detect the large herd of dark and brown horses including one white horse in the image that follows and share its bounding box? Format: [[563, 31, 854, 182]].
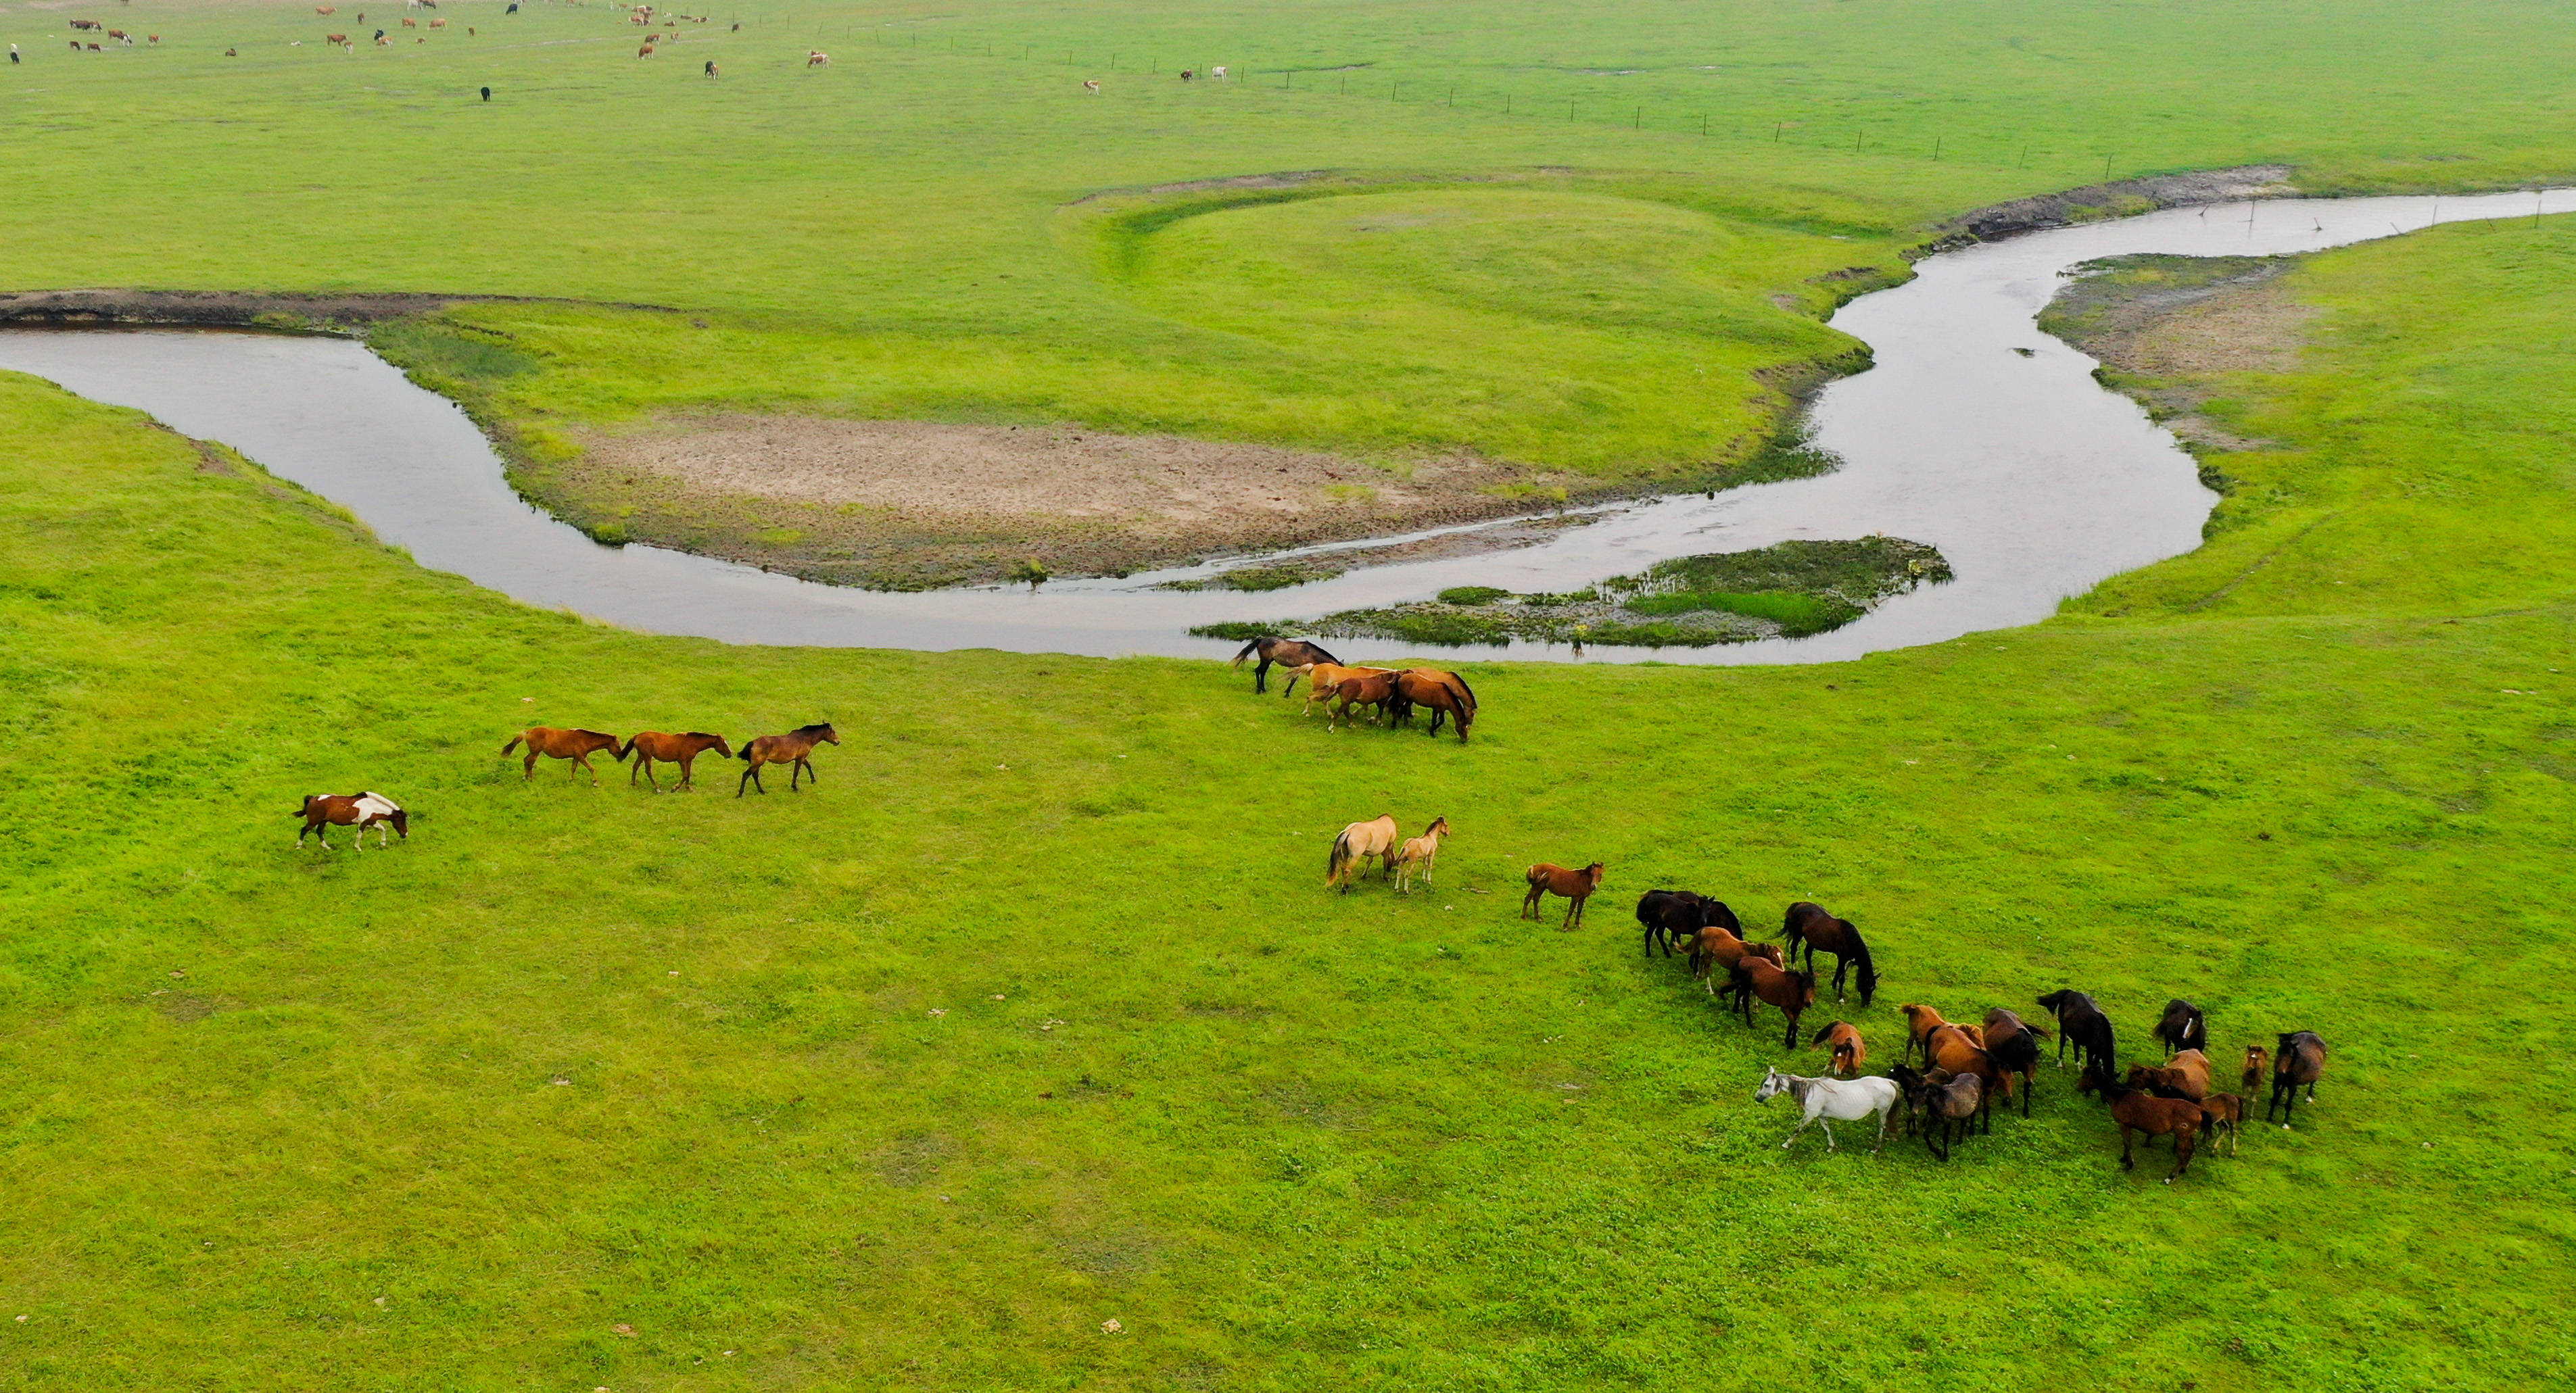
[[1636, 891, 2326, 1182]]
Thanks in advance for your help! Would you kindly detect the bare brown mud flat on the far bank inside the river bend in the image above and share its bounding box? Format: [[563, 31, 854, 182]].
[[564, 414, 1590, 589]]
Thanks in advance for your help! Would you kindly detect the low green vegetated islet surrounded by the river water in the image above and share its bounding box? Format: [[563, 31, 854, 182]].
[[1190, 535, 1950, 649]]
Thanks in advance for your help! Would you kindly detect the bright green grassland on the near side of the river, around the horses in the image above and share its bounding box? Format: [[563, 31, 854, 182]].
[[0, 190, 2576, 1393]]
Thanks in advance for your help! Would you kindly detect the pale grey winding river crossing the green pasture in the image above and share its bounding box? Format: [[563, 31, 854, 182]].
[[0, 191, 2576, 662]]
